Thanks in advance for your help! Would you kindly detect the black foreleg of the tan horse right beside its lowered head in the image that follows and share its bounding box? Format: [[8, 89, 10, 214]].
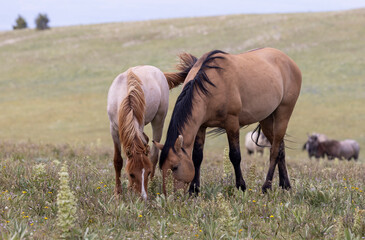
[[189, 127, 206, 194]]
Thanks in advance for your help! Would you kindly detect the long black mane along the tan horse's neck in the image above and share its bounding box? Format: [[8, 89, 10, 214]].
[[159, 50, 226, 168]]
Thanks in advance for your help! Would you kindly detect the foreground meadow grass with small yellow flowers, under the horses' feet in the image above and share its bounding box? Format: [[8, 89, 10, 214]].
[[0, 143, 365, 239]]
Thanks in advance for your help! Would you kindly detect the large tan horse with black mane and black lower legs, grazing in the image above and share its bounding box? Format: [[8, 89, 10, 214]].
[[155, 48, 302, 193]]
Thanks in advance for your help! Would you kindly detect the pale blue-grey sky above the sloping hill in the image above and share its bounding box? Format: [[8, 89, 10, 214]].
[[0, 0, 365, 31]]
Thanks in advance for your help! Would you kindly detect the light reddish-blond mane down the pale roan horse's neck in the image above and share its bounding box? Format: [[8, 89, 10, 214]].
[[118, 69, 146, 154]]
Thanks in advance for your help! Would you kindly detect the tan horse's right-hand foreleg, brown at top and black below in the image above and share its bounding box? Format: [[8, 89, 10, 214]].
[[225, 116, 246, 191]]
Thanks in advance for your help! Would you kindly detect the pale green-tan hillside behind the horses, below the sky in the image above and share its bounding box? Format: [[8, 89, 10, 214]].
[[0, 9, 365, 159]]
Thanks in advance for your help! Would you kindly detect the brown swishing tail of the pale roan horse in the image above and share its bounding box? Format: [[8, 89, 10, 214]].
[[164, 53, 198, 89]]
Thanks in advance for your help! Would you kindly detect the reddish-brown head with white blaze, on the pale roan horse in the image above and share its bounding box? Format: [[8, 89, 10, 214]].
[[125, 144, 152, 200]]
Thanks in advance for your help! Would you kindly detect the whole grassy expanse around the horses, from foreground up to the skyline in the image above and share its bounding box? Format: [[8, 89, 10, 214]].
[[0, 9, 365, 239]]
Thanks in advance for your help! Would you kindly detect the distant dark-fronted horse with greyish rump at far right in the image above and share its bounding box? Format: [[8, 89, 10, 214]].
[[310, 137, 360, 160]]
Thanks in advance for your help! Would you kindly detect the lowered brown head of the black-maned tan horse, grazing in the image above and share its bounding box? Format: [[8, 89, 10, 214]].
[[154, 135, 195, 194]]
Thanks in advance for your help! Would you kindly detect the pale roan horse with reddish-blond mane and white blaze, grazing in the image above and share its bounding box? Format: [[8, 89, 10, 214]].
[[107, 54, 196, 199]]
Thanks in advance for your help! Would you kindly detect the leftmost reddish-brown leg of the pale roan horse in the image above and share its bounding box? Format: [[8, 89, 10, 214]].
[[111, 127, 123, 195]]
